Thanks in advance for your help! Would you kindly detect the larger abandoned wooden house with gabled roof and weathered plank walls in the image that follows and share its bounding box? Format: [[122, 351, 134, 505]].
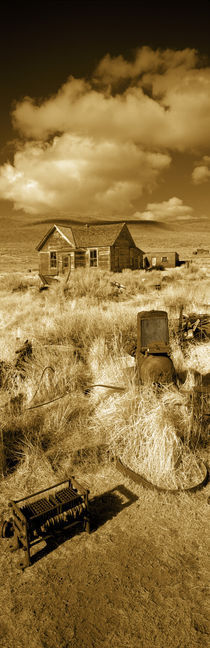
[[36, 223, 144, 283]]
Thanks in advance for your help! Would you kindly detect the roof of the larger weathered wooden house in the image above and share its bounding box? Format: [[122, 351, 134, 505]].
[[37, 223, 144, 250]]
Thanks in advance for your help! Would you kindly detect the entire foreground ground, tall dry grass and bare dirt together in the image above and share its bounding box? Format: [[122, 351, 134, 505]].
[[0, 263, 210, 648]]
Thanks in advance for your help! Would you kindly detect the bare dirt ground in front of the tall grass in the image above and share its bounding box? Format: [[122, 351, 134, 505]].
[[0, 464, 209, 648]]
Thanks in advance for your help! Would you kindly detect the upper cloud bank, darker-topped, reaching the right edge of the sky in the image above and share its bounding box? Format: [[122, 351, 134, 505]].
[[13, 47, 210, 151]]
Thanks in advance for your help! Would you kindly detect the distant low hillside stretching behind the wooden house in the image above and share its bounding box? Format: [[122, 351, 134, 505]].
[[0, 212, 210, 271]]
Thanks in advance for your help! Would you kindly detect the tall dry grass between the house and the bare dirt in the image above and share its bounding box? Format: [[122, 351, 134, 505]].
[[0, 268, 209, 494]]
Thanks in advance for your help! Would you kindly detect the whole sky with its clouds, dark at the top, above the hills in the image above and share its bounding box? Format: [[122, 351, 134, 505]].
[[0, 0, 210, 233]]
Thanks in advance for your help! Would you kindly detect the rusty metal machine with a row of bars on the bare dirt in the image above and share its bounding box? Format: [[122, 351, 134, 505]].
[[0, 477, 90, 569]]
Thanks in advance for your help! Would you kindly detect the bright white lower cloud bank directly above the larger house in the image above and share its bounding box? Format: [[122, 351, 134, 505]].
[[0, 133, 170, 217]]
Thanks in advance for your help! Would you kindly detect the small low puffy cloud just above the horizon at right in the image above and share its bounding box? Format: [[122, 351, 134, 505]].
[[134, 196, 193, 222]]
